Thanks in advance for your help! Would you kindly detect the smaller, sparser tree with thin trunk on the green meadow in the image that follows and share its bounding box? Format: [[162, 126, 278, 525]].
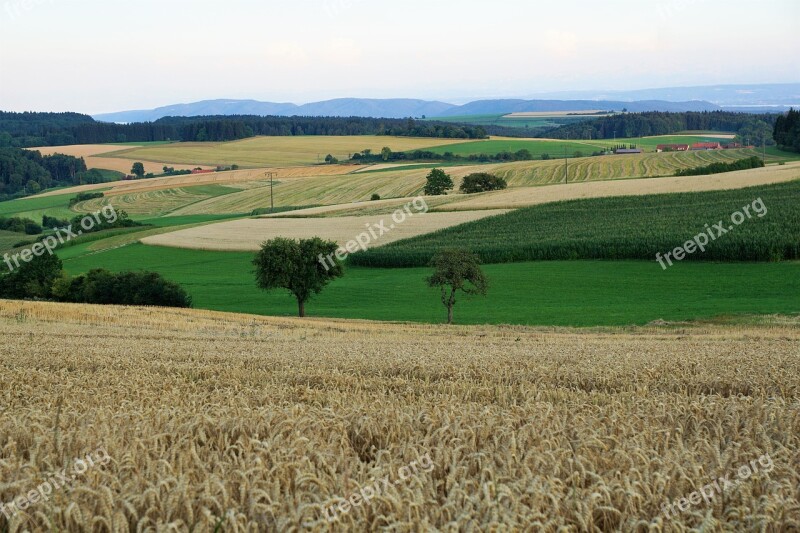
[[427, 250, 489, 324]]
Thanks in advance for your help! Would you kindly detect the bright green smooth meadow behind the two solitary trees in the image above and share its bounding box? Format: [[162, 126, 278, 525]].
[[61, 244, 800, 326]]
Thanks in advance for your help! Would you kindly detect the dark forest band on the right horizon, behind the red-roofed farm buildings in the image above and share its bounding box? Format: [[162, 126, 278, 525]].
[[540, 111, 780, 145]]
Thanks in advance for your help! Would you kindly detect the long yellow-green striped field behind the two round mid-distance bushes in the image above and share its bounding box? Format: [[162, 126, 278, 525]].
[[67, 150, 790, 215]]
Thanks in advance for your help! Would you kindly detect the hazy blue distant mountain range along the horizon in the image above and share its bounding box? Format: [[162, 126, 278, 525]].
[[93, 84, 800, 122]]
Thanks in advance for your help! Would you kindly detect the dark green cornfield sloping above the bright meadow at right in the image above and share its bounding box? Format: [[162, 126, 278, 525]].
[[349, 180, 800, 267]]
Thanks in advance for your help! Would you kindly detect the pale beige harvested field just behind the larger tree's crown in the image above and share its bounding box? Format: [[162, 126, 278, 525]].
[[142, 208, 506, 251]]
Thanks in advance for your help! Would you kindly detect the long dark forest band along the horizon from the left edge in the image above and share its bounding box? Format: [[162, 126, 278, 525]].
[[0, 111, 519, 148]]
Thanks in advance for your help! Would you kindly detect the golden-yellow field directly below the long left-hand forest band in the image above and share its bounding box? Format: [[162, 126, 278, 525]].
[[99, 135, 464, 168]]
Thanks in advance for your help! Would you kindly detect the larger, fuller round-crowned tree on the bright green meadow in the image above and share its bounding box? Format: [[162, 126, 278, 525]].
[[253, 237, 344, 317]]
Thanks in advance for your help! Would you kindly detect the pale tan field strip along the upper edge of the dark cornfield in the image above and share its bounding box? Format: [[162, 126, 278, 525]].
[[435, 163, 800, 211]]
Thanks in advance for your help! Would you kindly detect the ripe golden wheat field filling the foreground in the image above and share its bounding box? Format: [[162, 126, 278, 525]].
[[0, 300, 800, 532]]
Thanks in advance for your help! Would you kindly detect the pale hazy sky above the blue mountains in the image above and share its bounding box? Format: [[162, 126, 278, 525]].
[[0, 0, 800, 113]]
